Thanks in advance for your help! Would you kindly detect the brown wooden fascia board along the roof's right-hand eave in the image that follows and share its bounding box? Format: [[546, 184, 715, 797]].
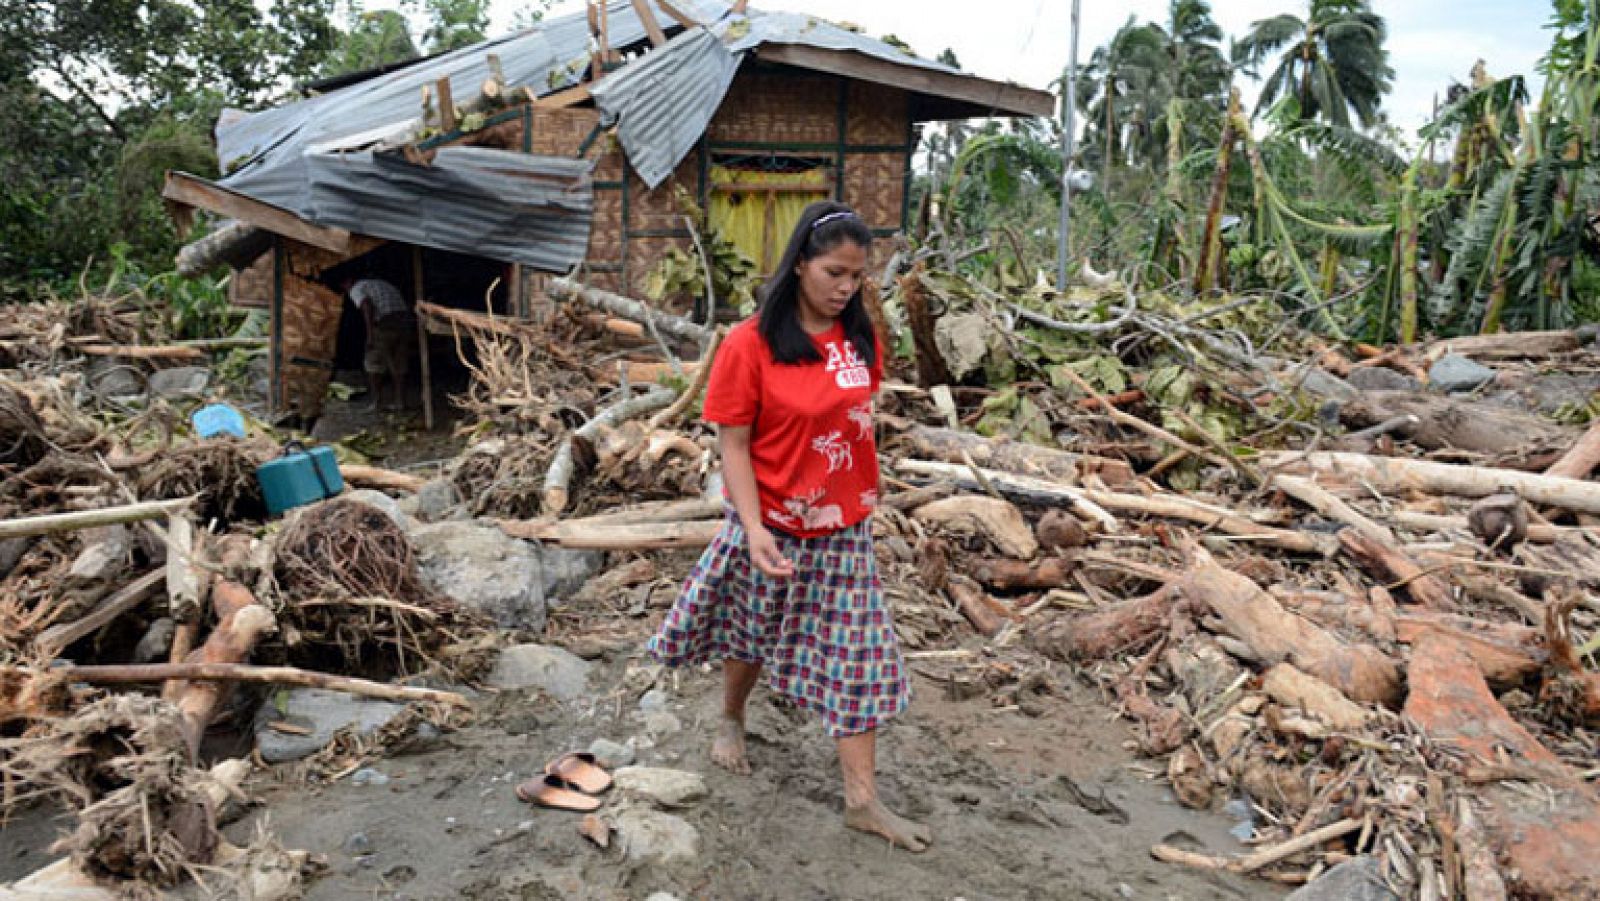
[[755, 43, 1056, 117]]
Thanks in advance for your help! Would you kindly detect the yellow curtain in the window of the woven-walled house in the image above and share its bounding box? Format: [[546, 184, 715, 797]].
[[710, 166, 832, 274]]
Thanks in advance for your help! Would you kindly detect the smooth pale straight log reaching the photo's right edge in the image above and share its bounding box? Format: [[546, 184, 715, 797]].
[[1262, 451, 1600, 514]]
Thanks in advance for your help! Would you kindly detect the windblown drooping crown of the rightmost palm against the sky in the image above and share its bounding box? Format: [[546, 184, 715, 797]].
[[1235, 0, 1395, 128]]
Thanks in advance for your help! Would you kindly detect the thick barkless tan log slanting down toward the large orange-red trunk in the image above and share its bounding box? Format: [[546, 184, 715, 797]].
[[1179, 547, 1400, 704]]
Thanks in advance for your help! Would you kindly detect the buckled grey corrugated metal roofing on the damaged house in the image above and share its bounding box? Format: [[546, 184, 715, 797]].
[[171, 0, 1053, 270]]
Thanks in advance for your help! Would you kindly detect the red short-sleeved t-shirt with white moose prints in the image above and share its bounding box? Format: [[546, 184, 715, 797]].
[[702, 318, 883, 538]]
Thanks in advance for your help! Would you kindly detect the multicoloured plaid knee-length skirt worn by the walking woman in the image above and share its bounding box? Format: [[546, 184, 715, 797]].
[[648, 514, 910, 738]]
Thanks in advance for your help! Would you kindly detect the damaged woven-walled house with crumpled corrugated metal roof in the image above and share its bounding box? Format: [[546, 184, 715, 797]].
[[163, 0, 1054, 416]]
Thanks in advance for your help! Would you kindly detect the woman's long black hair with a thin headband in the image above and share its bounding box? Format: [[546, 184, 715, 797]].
[[760, 200, 877, 366]]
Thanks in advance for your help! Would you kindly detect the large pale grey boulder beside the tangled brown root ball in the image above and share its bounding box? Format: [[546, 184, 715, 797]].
[[411, 522, 546, 632]]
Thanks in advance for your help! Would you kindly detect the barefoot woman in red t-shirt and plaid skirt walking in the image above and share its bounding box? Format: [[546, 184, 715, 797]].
[[650, 202, 930, 851]]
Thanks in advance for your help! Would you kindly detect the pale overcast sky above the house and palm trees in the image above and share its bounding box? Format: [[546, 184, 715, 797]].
[[467, 0, 1550, 136]]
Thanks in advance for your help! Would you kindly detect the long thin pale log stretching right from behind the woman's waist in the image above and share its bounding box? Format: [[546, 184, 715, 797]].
[[894, 459, 1338, 557]]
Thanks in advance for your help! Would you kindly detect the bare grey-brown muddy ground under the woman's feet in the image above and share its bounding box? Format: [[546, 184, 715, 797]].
[[219, 661, 1283, 901]]
